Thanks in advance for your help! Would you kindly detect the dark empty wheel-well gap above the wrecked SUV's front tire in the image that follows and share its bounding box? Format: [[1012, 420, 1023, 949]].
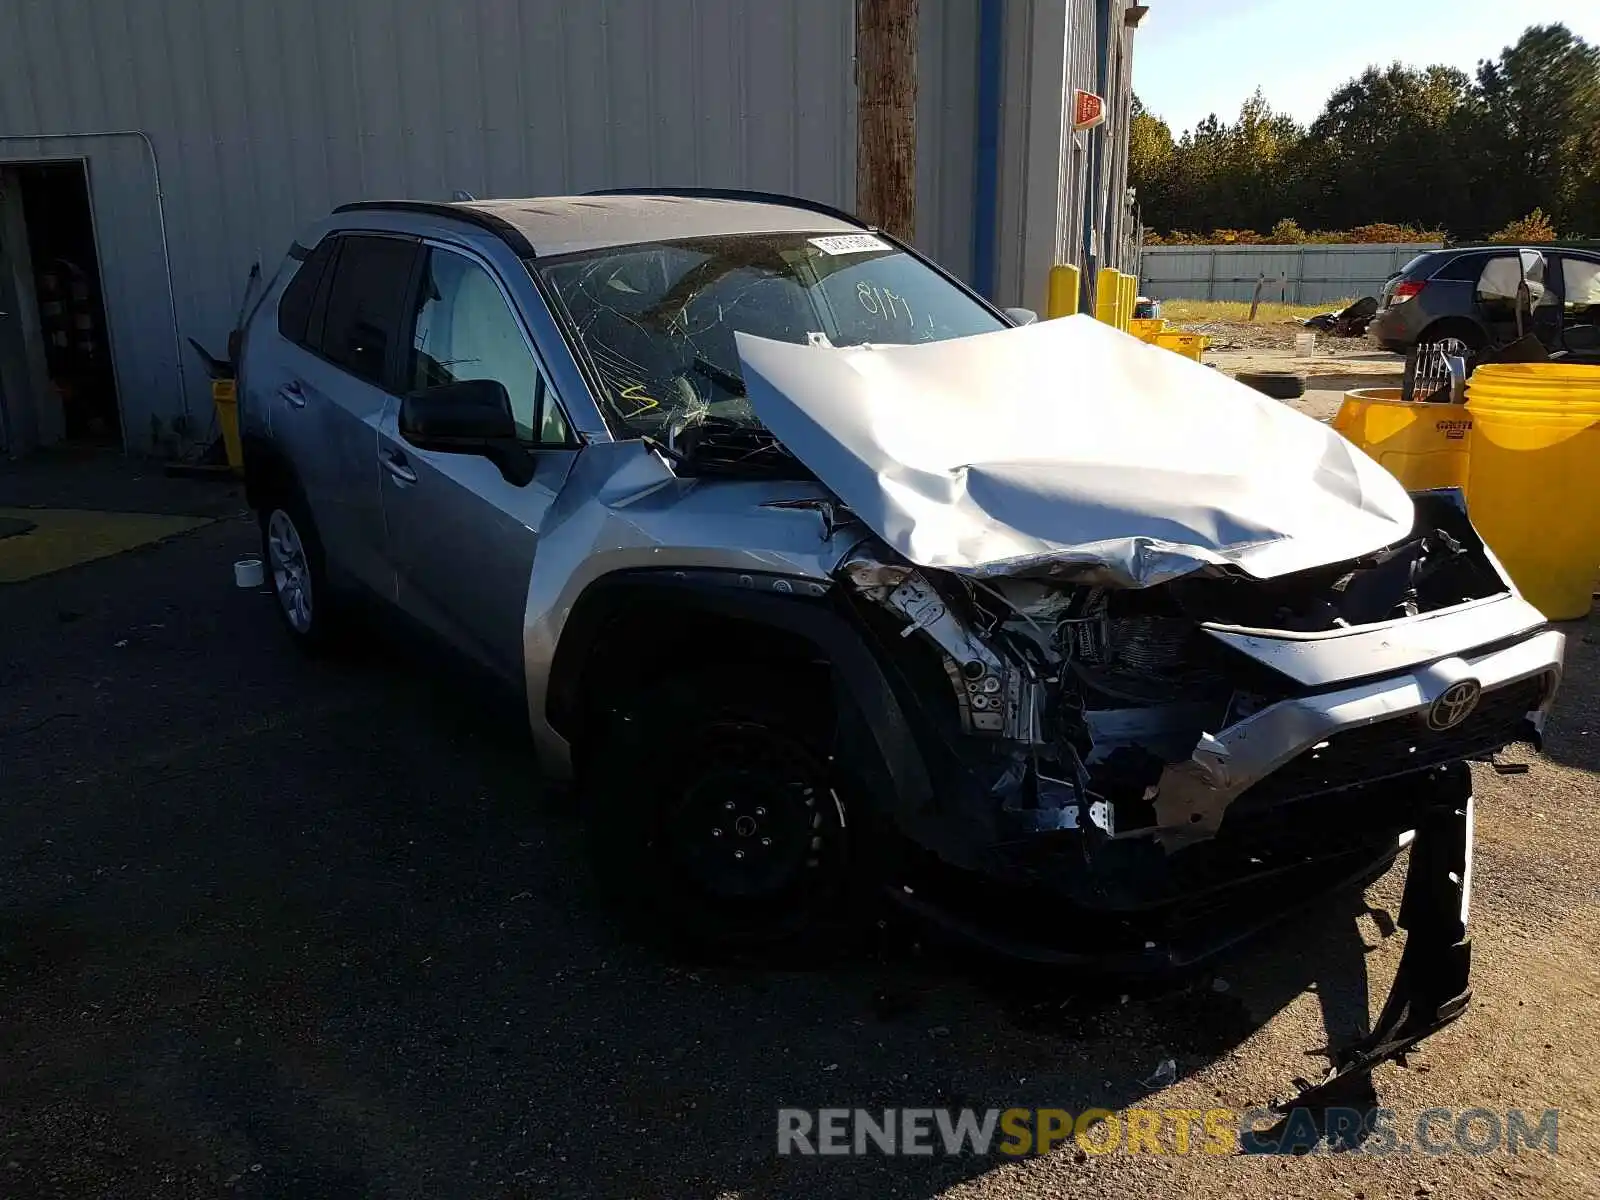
[[547, 586, 832, 744]]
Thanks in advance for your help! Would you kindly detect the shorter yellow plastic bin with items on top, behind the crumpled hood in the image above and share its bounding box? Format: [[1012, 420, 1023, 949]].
[[1333, 387, 1472, 491]]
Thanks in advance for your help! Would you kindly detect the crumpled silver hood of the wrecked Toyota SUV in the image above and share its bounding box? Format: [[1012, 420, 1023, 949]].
[[738, 317, 1413, 587]]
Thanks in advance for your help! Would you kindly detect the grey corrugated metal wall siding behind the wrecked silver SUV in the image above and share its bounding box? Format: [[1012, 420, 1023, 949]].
[[0, 0, 870, 450]]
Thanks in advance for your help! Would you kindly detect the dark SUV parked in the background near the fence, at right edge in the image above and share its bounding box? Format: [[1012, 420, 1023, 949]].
[[1368, 246, 1600, 362]]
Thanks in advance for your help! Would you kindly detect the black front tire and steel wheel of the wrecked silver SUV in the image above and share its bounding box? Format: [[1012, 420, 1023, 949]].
[[582, 669, 859, 960]]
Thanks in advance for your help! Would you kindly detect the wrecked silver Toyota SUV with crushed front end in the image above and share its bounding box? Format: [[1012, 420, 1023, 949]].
[[238, 192, 1563, 1107]]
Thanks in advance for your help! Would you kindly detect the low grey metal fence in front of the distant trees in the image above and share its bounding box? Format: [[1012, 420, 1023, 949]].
[[1139, 242, 1440, 304]]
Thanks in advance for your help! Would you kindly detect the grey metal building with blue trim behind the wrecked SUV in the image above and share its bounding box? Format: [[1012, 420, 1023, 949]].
[[0, 0, 1146, 454]]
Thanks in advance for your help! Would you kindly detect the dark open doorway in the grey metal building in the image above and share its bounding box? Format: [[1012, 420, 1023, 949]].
[[0, 160, 122, 446]]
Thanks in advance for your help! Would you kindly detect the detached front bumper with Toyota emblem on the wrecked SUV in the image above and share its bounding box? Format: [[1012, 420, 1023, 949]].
[[891, 630, 1565, 974]]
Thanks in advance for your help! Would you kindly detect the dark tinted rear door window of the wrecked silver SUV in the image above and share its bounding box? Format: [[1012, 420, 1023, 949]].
[[312, 234, 416, 386]]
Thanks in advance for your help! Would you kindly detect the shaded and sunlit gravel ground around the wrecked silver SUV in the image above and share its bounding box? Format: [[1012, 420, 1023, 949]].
[[0, 496, 1600, 1200]]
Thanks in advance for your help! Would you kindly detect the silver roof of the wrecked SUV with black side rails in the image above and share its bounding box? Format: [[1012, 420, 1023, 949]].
[[338, 190, 864, 258]]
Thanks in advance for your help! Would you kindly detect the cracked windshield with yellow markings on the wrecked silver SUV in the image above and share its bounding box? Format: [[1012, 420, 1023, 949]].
[[534, 234, 1005, 443]]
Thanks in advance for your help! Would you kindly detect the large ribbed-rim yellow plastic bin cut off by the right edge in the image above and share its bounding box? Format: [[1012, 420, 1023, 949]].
[[1467, 363, 1600, 621]]
